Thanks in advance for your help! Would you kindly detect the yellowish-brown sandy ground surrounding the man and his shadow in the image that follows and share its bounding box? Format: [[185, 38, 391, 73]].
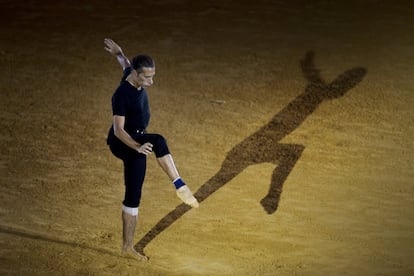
[[0, 0, 414, 275]]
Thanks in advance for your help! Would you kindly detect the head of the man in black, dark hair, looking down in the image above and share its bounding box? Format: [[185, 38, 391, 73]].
[[132, 55, 155, 88]]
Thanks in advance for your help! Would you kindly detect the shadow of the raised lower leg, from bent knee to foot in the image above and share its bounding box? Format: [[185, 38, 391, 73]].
[[260, 145, 305, 215]]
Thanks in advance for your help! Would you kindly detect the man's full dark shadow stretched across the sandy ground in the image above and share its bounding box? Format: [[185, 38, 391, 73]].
[[135, 52, 366, 254]]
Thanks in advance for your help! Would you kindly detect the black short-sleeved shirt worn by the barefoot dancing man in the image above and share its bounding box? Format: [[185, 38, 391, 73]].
[[112, 67, 150, 135]]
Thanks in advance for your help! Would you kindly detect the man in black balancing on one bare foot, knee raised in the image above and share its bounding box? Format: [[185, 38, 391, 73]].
[[104, 38, 199, 260]]
